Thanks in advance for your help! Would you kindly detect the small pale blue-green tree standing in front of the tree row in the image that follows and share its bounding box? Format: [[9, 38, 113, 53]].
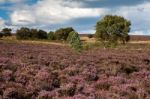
[[68, 31, 82, 52]]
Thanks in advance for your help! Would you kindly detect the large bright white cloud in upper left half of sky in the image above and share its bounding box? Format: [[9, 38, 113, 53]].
[[10, 0, 105, 25]]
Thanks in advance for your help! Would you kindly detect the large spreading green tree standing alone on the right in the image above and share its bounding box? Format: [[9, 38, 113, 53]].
[[95, 15, 131, 46]]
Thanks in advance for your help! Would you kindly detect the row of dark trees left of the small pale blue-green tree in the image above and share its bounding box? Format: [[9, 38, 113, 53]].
[[16, 27, 75, 41]]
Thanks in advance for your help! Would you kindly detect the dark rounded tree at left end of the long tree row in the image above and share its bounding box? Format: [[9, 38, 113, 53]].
[[16, 27, 31, 40]]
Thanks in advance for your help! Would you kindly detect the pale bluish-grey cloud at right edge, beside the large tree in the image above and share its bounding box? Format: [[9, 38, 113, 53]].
[[115, 2, 150, 34]]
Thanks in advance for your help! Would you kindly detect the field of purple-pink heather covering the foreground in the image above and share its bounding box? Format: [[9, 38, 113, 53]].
[[0, 42, 150, 99]]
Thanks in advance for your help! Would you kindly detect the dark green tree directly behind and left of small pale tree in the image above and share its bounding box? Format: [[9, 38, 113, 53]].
[[55, 27, 74, 40]]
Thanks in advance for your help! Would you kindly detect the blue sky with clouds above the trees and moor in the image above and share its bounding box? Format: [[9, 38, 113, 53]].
[[0, 0, 150, 35]]
